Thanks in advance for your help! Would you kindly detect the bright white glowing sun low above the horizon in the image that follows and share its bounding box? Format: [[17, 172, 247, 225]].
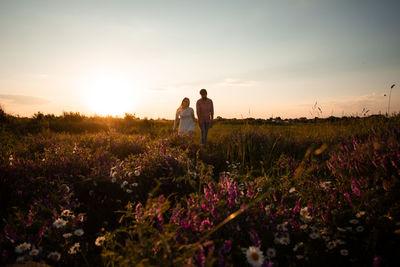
[[84, 75, 136, 116]]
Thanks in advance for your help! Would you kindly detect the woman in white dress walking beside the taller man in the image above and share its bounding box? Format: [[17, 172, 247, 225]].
[[174, 97, 196, 135]]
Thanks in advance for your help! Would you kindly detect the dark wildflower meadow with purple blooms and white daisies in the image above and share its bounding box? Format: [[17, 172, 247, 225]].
[[0, 112, 400, 266]]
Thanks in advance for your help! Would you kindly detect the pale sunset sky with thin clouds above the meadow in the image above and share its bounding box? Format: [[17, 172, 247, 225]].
[[0, 0, 400, 119]]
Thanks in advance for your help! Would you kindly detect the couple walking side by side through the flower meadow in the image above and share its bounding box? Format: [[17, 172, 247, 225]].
[[174, 89, 214, 145]]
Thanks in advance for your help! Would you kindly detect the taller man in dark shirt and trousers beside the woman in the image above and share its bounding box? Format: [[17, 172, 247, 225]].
[[196, 89, 214, 145]]
